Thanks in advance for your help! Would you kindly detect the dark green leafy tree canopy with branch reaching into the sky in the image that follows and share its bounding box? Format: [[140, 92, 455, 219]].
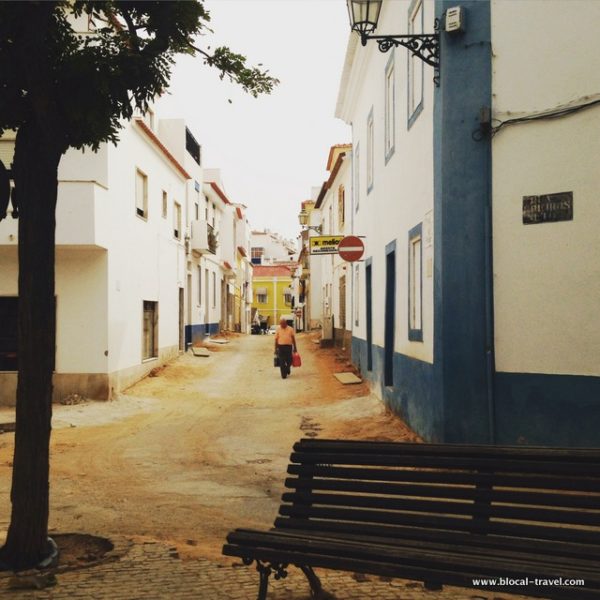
[[0, 0, 278, 152]]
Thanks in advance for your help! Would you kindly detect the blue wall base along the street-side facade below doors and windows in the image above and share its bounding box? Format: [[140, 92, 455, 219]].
[[352, 337, 443, 442]]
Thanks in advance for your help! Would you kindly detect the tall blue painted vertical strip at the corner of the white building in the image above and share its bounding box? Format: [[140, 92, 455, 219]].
[[434, 0, 493, 443]]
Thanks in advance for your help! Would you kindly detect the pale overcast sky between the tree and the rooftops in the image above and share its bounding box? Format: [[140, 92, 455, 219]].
[[157, 0, 351, 238]]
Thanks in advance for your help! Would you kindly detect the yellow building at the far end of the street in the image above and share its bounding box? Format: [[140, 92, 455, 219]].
[[252, 265, 296, 327]]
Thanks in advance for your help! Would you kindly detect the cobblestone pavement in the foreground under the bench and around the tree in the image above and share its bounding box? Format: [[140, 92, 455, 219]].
[[0, 540, 544, 600]]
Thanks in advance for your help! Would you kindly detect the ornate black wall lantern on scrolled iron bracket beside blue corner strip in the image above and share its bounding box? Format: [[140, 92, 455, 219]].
[[346, 0, 440, 74]]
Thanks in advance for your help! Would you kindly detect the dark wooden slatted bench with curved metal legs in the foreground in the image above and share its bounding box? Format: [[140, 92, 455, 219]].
[[223, 439, 600, 600]]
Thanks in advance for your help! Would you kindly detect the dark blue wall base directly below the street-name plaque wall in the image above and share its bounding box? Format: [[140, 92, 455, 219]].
[[494, 373, 600, 448]]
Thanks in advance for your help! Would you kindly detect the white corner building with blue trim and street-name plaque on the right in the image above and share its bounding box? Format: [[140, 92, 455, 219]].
[[336, 0, 600, 446]]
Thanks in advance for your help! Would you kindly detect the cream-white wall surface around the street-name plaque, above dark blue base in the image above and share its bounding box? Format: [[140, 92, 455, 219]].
[[491, 0, 600, 376]]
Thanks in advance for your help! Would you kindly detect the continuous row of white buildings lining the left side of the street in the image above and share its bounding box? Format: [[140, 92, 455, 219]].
[[0, 110, 252, 405]]
